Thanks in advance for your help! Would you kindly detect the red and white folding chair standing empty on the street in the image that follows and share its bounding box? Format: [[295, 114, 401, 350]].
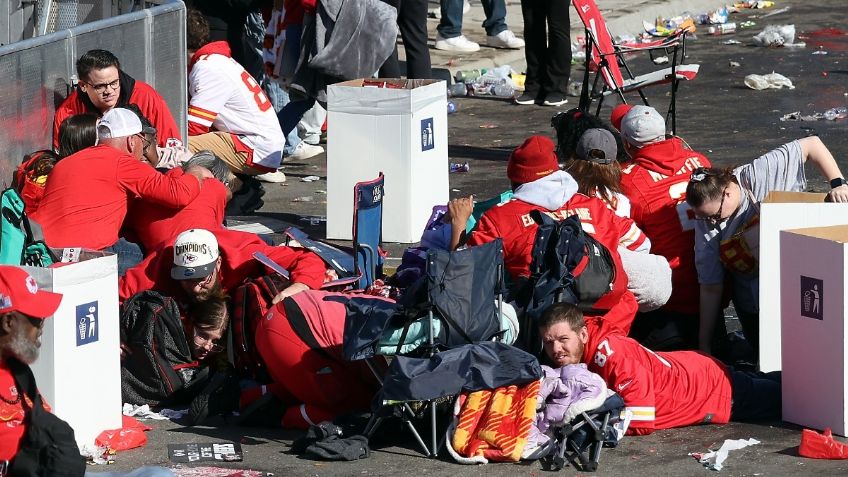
[[571, 0, 700, 134]]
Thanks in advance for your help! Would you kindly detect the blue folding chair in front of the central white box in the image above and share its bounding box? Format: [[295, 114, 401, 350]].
[[283, 172, 385, 290]]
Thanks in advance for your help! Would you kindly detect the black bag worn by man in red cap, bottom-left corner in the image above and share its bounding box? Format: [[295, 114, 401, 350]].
[[7, 359, 85, 477]]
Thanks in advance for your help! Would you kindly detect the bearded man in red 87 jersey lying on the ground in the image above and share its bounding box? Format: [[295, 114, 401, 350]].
[[538, 303, 781, 435]]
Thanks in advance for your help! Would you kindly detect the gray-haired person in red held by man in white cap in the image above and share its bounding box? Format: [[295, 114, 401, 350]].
[[124, 150, 235, 255]]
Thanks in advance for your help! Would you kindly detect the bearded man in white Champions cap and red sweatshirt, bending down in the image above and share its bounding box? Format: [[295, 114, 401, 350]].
[[118, 228, 326, 304]]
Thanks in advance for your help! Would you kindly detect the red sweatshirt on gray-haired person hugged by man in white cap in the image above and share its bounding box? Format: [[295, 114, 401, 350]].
[[123, 172, 227, 252]]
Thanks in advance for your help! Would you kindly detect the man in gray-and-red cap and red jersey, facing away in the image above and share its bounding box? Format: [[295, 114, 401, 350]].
[[620, 105, 710, 348]]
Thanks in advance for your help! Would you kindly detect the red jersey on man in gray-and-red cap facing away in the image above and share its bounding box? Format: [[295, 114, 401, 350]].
[[621, 138, 710, 315]]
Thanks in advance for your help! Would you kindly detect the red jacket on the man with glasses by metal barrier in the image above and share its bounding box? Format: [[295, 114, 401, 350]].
[[53, 70, 183, 148]]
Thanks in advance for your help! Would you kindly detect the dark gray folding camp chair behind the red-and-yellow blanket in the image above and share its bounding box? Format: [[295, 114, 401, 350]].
[[344, 239, 520, 456]]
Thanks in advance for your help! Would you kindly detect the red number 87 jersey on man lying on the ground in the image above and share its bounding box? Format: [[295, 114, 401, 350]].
[[583, 318, 732, 435]]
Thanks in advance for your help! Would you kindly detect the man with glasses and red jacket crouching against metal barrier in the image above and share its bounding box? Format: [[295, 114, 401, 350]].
[[53, 50, 182, 148]]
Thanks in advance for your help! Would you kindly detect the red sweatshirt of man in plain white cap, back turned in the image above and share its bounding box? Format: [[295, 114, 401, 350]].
[[32, 145, 200, 250]]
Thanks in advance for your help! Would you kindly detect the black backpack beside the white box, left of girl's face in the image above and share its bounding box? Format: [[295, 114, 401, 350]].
[[120, 290, 210, 407]]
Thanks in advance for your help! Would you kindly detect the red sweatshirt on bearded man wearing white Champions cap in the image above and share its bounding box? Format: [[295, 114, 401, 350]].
[[118, 228, 326, 301]]
